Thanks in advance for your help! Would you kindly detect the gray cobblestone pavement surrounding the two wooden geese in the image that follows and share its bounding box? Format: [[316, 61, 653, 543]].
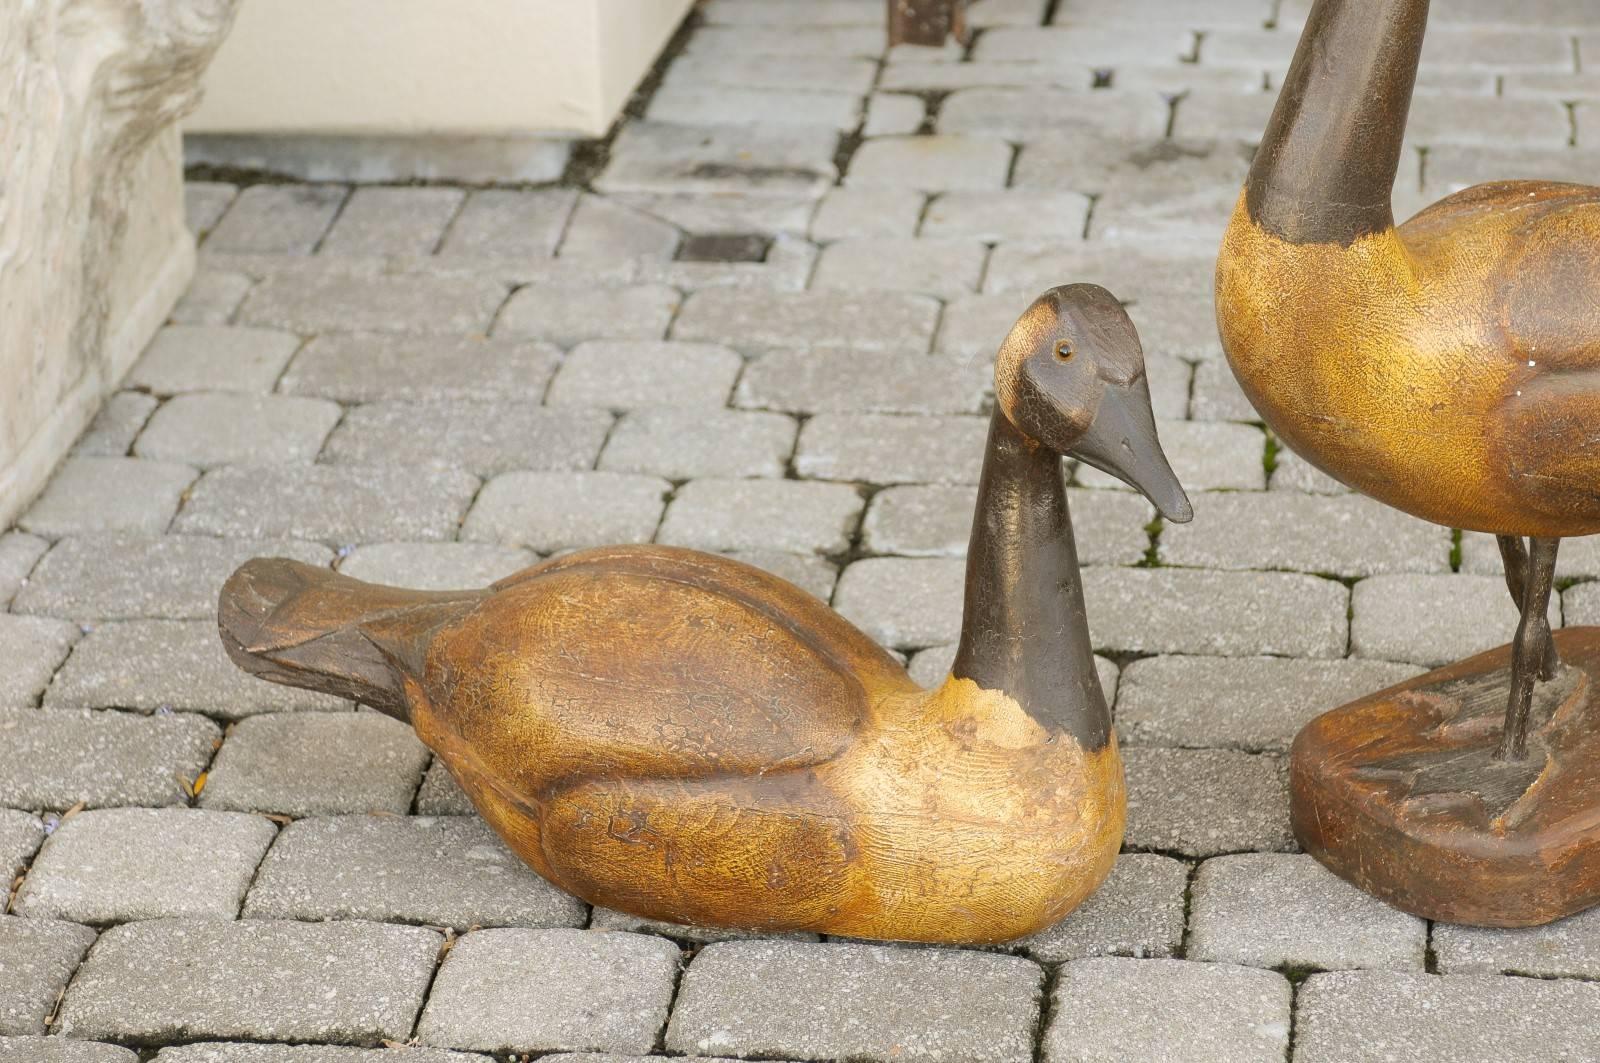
[[9, 0, 1600, 1063]]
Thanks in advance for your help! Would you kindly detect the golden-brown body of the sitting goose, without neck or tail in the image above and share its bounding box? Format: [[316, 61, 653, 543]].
[[406, 548, 1126, 943]]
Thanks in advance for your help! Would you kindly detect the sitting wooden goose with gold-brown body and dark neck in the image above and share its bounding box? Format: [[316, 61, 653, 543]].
[[219, 285, 1190, 943]]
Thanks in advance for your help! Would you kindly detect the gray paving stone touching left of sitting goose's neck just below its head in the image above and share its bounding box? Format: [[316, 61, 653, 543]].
[[795, 413, 989, 483]]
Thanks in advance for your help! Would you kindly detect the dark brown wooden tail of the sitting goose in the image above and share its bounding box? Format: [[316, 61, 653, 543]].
[[218, 557, 488, 722]]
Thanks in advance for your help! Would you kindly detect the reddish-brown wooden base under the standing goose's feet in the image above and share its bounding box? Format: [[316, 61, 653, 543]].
[[1290, 628, 1600, 927]]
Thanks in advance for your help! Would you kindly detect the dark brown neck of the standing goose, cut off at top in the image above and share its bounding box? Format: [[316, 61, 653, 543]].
[[1245, 0, 1429, 245]]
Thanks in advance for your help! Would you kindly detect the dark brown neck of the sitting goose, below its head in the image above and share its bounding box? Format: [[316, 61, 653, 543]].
[[950, 410, 1110, 751]]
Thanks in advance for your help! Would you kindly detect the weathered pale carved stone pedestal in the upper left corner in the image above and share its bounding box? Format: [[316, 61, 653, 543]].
[[0, 0, 237, 528]]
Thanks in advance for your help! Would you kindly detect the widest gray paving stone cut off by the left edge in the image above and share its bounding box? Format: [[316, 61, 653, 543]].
[[0, 709, 222, 810]]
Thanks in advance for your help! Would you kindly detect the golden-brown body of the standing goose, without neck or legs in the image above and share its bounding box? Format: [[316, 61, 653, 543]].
[[1216, 181, 1600, 536]]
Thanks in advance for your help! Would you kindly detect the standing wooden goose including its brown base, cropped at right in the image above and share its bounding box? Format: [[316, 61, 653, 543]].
[[1216, 0, 1600, 927]]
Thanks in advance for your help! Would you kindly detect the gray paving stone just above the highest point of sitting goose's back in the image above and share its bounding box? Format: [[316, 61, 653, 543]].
[[461, 472, 672, 552]]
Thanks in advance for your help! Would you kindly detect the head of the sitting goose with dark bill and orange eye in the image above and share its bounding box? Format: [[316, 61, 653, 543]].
[[995, 285, 1194, 523]]
